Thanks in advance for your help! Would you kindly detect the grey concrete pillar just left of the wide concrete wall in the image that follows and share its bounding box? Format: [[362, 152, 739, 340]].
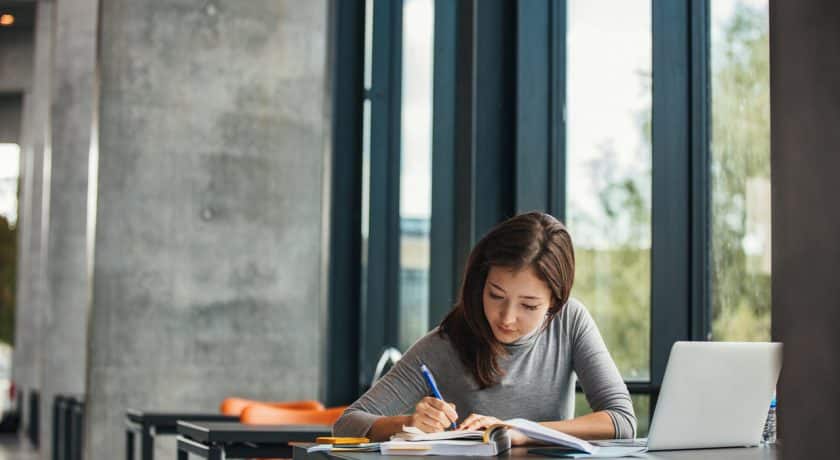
[[40, 0, 98, 458]]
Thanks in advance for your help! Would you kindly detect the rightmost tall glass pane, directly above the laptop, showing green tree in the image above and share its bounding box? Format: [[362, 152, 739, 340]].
[[711, 0, 770, 341]]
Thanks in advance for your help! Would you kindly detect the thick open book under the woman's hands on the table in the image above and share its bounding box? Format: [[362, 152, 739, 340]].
[[381, 418, 598, 456]]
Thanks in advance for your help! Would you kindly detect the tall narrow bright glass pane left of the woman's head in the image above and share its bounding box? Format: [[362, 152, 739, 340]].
[[399, 0, 434, 350]]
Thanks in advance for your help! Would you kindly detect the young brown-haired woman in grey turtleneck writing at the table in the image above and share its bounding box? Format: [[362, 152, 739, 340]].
[[334, 212, 636, 445]]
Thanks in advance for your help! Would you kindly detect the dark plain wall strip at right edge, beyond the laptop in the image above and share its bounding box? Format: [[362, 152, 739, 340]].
[[770, 0, 840, 458]]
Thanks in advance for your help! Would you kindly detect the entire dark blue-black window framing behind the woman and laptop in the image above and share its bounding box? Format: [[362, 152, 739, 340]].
[[326, 0, 711, 420]]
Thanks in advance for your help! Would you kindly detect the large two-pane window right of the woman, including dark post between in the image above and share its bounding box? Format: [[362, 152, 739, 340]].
[[564, 0, 770, 435]]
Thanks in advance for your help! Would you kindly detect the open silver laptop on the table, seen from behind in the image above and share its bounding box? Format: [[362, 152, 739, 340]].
[[594, 342, 782, 451]]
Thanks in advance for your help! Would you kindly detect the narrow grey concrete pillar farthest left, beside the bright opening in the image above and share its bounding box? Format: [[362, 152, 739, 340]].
[[13, 1, 53, 442]]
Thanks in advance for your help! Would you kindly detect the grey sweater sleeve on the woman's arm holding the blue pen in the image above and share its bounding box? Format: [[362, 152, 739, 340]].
[[333, 332, 438, 436]]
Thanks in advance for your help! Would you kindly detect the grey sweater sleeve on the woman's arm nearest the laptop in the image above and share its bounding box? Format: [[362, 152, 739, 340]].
[[567, 300, 636, 438]]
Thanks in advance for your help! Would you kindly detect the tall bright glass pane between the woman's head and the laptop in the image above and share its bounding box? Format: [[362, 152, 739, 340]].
[[566, 0, 651, 381]]
